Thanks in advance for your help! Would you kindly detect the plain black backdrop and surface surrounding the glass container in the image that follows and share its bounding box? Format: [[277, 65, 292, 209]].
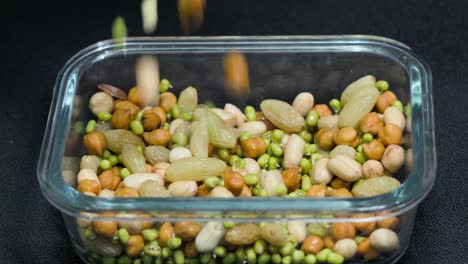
[[0, 0, 468, 264]]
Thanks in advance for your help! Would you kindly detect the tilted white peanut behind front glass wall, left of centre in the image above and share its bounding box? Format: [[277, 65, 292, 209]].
[[195, 221, 225, 253]]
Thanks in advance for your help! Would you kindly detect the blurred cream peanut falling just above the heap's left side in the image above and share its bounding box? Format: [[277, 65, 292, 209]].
[[135, 55, 160, 107]]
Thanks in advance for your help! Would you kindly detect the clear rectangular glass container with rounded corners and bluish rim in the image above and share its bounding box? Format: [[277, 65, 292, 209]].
[[37, 35, 436, 263]]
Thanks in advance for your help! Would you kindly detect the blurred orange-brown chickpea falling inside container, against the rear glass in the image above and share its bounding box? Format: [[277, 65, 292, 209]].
[[223, 51, 250, 97]]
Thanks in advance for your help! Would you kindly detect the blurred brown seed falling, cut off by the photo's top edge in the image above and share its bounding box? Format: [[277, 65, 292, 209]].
[[177, 0, 205, 34]]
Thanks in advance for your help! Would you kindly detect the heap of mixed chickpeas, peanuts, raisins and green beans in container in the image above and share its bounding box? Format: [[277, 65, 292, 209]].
[[78, 73, 409, 263]]
